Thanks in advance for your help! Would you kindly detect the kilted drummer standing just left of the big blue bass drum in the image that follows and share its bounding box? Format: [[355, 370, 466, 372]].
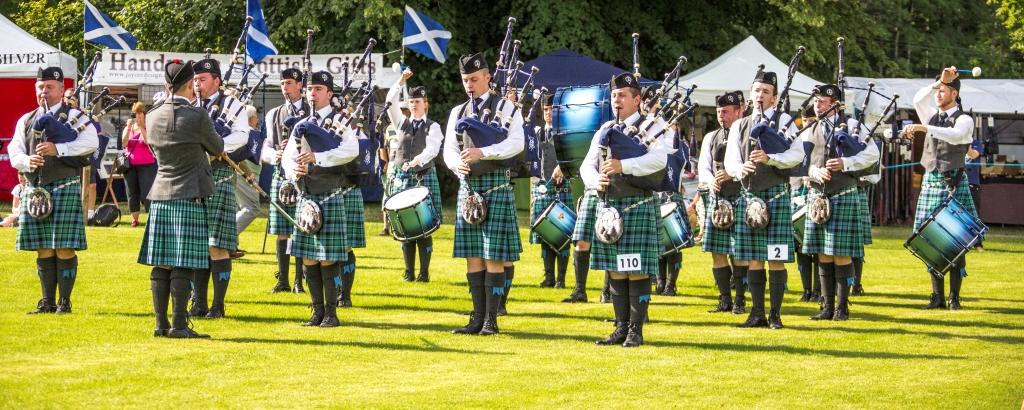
[[529, 94, 572, 289]]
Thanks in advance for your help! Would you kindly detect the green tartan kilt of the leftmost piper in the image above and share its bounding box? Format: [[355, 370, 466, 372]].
[[14, 176, 87, 250]]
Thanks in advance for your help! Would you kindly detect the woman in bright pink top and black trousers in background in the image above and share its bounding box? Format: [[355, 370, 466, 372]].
[[121, 101, 157, 227]]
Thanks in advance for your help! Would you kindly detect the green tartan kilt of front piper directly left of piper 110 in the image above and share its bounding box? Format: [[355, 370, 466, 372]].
[[452, 170, 522, 261]]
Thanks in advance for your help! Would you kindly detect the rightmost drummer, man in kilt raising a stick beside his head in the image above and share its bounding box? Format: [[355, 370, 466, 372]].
[[903, 67, 978, 311]]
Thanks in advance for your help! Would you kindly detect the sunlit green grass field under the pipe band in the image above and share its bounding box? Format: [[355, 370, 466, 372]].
[[0, 207, 1024, 409]]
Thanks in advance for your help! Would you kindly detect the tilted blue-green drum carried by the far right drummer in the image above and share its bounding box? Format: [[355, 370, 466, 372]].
[[903, 197, 988, 275]]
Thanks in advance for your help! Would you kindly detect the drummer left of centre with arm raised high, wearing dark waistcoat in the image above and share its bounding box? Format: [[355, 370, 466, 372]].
[[386, 69, 444, 282]]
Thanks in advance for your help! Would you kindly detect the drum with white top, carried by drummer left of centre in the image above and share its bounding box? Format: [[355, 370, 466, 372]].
[[384, 187, 441, 241]]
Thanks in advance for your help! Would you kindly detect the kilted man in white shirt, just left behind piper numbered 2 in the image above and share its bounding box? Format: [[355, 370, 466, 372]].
[[697, 92, 746, 315]]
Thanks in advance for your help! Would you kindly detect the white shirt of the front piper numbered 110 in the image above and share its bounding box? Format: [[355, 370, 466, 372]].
[[580, 112, 675, 190]]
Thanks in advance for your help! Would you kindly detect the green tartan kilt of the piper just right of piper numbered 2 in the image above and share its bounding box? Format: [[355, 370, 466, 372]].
[[801, 187, 864, 257]]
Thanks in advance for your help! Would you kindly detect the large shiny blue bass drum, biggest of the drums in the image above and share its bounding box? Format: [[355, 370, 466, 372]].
[[551, 85, 611, 176]]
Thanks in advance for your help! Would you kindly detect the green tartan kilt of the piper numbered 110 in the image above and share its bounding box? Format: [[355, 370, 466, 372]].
[[590, 195, 662, 276]]
